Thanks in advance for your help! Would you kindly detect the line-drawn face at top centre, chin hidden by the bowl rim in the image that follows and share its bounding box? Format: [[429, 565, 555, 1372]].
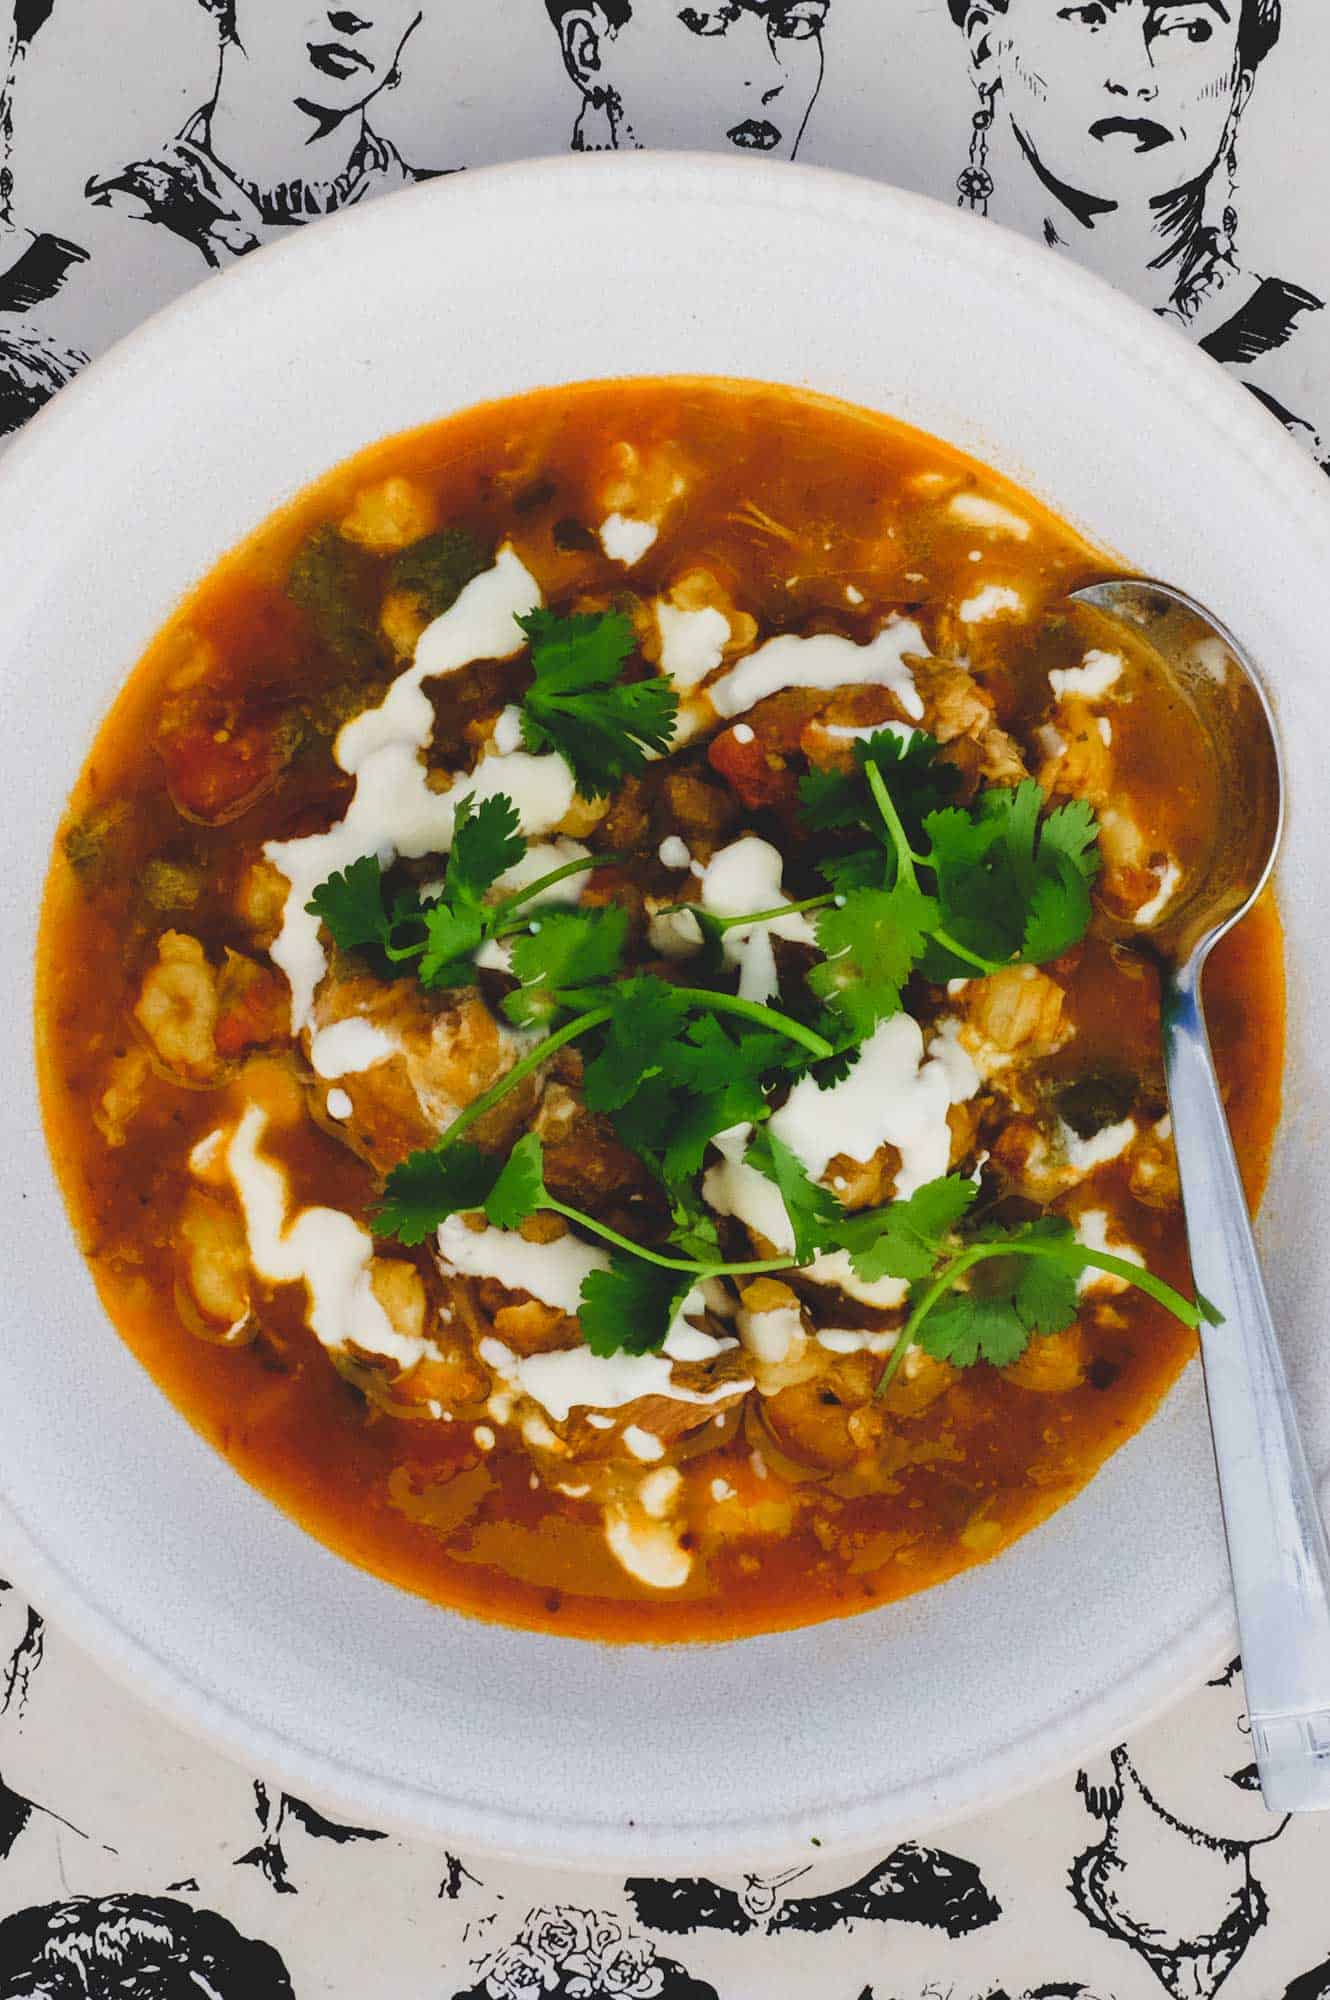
[[560, 0, 830, 160]]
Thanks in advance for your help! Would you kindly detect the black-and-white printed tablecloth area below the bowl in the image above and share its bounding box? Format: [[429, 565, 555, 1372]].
[[0, 1584, 1330, 2000]]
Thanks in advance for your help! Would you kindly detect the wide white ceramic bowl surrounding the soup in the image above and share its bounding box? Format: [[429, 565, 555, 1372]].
[[0, 156, 1330, 1868]]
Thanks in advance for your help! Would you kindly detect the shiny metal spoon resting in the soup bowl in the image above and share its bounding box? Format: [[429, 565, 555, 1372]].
[[1072, 578, 1330, 1812]]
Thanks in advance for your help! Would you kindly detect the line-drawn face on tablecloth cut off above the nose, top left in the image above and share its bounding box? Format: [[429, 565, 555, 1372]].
[[234, 0, 420, 122]]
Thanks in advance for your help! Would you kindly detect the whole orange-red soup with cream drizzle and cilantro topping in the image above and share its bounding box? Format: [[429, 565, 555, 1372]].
[[38, 380, 1284, 1640]]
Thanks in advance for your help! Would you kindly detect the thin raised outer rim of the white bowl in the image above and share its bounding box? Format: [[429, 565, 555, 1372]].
[[0, 154, 1330, 1868]]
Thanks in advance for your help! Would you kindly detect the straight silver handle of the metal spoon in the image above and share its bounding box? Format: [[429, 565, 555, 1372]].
[[1164, 960, 1330, 1812]]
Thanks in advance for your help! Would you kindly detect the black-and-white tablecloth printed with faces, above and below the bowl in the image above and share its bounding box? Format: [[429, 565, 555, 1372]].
[[0, 0, 1330, 2000]]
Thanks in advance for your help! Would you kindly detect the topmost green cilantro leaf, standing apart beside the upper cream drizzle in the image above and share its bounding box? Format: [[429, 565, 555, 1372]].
[[518, 610, 678, 798]]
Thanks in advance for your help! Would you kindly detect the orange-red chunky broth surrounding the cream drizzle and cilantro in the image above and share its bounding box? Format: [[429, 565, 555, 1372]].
[[38, 380, 1284, 1640]]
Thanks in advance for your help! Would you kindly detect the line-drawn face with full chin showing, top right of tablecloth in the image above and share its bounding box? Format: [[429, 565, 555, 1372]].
[[968, 0, 1246, 204]]
